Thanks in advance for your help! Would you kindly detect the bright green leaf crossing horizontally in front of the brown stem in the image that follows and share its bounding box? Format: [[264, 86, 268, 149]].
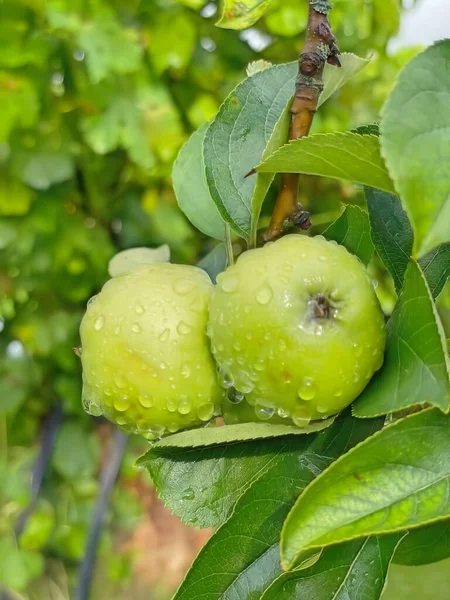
[[256, 132, 394, 192]]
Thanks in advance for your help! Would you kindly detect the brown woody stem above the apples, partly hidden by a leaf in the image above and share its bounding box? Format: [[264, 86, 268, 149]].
[[263, 0, 341, 242]]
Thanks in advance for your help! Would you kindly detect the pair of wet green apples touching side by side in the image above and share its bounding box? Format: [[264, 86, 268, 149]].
[[81, 235, 386, 438]]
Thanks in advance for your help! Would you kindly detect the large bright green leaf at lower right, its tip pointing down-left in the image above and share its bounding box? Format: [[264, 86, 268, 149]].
[[281, 409, 450, 566]]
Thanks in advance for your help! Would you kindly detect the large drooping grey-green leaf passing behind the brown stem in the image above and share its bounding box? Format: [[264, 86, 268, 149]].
[[203, 54, 367, 238]]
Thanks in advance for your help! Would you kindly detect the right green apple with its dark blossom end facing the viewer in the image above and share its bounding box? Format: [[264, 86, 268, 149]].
[[208, 235, 386, 426]]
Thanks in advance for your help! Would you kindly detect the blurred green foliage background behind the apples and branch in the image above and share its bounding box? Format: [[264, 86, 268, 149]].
[[0, 0, 450, 600]]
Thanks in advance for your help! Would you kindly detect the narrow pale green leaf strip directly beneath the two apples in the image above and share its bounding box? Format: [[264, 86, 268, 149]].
[[140, 419, 333, 452]]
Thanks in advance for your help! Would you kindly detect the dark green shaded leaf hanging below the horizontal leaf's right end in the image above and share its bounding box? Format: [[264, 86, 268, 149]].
[[365, 187, 414, 293]]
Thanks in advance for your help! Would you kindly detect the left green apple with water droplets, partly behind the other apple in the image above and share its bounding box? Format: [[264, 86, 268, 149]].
[[80, 263, 222, 437]]
